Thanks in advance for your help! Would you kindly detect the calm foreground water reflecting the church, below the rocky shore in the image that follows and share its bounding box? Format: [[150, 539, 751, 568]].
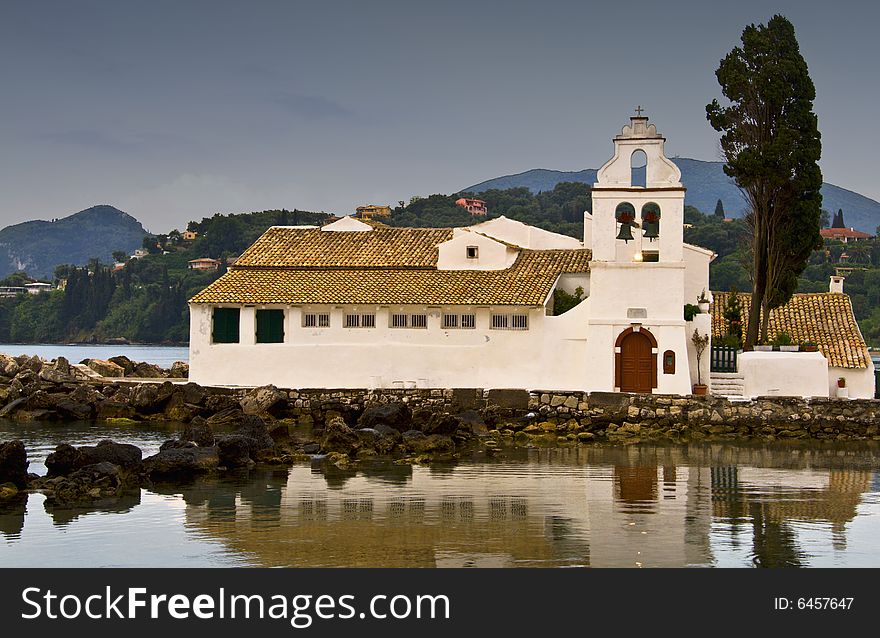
[[0, 422, 880, 567]]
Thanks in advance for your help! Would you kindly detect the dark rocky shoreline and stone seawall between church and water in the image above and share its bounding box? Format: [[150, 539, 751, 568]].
[[0, 355, 880, 503]]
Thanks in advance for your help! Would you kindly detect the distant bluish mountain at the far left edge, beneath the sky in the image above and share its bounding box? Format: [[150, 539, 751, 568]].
[[0, 206, 147, 279]]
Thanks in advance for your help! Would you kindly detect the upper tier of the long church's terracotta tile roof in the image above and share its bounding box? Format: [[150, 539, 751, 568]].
[[235, 225, 452, 268]]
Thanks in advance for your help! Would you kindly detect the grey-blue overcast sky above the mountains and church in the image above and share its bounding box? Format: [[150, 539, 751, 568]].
[[0, 0, 880, 232]]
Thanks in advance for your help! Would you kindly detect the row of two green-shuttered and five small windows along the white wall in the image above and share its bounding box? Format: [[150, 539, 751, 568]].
[[211, 308, 529, 343]]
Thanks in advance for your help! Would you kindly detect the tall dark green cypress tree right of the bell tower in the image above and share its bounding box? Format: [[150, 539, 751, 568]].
[[706, 15, 822, 347]]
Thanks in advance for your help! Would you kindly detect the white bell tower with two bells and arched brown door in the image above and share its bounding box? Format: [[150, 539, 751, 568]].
[[584, 107, 695, 394]]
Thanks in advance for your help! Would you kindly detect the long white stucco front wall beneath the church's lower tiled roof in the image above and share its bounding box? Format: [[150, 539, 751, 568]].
[[190, 302, 593, 390]]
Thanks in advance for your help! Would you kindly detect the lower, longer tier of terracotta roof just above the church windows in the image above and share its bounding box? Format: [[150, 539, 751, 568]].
[[190, 251, 590, 306]]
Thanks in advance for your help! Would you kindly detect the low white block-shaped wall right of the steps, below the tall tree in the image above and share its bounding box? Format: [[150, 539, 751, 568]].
[[737, 352, 837, 397]]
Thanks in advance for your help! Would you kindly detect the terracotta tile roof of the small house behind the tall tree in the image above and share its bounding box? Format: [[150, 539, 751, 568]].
[[711, 292, 873, 368]]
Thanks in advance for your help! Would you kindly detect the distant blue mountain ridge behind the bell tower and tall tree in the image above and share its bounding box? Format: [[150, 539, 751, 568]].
[[461, 157, 880, 235]]
